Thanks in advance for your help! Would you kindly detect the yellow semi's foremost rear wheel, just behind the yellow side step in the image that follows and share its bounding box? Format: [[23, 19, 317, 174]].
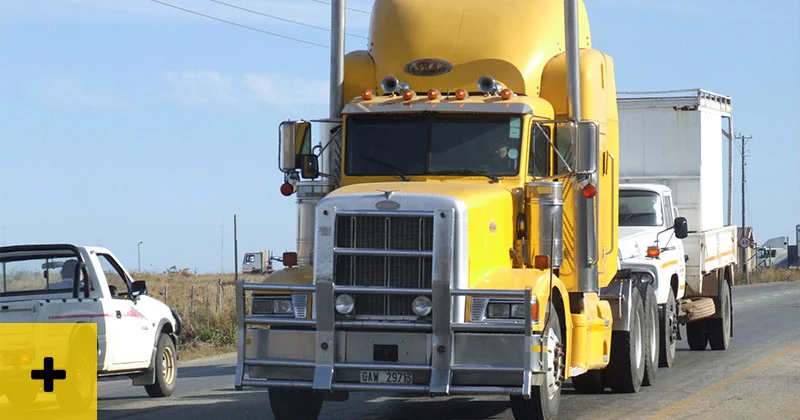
[[606, 293, 646, 393]]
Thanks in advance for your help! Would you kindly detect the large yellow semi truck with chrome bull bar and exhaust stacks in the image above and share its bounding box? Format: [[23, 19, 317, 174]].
[[235, 0, 658, 419]]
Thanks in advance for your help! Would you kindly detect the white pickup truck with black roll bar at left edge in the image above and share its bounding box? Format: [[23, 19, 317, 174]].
[[0, 244, 182, 404]]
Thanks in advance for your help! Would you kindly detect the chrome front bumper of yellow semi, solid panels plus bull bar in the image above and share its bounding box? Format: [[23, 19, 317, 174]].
[[235, 280, 547, 398]]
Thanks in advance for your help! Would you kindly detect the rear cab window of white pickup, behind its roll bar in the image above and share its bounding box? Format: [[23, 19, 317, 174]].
[[0, 253, 78, 296]]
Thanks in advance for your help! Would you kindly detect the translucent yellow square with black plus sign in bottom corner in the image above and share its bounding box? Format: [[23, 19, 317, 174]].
[[0, 323, 97, 420]]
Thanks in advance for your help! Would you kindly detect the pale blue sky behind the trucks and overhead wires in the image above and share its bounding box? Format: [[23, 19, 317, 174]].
[[0, 0, 800, 272]]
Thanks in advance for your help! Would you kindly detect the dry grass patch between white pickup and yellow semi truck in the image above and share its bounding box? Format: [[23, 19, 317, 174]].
[[134, 271, 264, 359]]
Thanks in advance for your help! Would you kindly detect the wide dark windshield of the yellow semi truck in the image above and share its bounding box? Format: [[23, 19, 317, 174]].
[[345, 113, 522, 177]]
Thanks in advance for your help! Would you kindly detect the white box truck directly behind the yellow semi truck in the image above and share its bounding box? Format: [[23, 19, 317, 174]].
[[618, 89, 737, 358]]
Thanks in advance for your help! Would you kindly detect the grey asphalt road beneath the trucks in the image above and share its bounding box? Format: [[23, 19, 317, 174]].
[[98, 283, 800, 420]]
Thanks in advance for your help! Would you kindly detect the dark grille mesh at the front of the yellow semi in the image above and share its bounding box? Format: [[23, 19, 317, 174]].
[[333, 215, 433, 317]]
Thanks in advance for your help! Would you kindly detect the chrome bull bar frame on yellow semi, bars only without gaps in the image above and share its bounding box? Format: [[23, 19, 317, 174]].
[[234, 279, 547, 399]]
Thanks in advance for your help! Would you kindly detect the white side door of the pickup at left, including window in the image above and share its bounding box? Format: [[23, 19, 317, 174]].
[[97, 254, 154, 369]]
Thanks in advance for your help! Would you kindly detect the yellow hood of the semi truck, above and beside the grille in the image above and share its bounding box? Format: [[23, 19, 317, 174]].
[[328, 181, 516, 286]]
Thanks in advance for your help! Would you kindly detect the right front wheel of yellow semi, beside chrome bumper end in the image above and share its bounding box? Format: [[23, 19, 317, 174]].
[[510, 303, 565, 420]]
